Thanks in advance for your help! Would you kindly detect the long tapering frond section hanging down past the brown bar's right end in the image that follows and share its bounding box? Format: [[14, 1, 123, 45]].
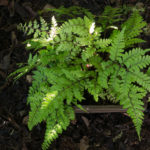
[[109, 69, 146, 138]]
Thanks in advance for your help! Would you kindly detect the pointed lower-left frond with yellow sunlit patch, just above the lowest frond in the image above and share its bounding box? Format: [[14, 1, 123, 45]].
[[28, 83, 54, 130]]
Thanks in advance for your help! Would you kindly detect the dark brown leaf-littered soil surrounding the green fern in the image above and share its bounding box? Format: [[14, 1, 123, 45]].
[[0, 0, 150, 150]]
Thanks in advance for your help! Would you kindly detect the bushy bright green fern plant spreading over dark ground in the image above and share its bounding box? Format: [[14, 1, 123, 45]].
[[11, 6, 150, 150]]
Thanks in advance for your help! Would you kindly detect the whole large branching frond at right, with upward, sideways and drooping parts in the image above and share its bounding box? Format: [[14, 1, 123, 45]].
[[106, 27, 150, 138]]
